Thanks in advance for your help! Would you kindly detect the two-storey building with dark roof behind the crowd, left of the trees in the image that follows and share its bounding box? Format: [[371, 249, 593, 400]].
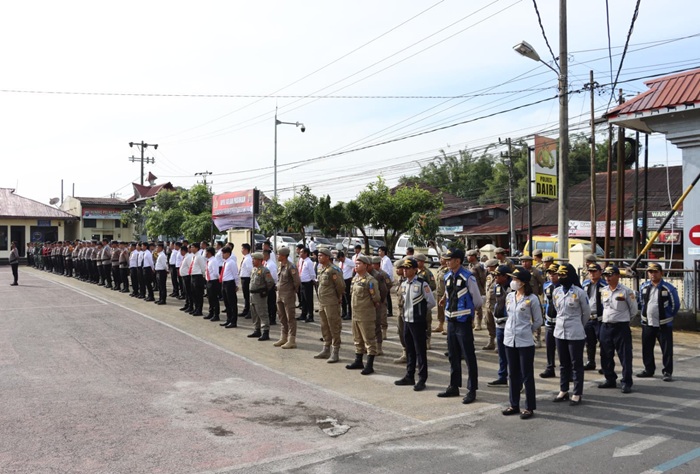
[[61, 196, 135, 241]]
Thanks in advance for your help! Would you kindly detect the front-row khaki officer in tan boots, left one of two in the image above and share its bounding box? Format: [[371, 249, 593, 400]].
[[273, 247, 301, 349]]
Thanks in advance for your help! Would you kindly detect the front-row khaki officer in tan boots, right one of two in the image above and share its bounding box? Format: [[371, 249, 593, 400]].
[[314, 248, 345, 363]]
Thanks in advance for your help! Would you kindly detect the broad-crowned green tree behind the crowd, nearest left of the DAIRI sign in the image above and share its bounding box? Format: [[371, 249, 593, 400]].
[[357, 177, 442, 254]]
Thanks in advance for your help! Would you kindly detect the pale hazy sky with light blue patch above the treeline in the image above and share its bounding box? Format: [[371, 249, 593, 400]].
[[0, 0, 700, 207]]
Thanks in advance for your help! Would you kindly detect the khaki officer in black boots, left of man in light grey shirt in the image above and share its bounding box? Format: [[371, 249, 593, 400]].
[[345, 255, 380, 375]]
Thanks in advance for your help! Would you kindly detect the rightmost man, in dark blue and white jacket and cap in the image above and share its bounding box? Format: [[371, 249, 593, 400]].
[[637, 263, 681, 382]]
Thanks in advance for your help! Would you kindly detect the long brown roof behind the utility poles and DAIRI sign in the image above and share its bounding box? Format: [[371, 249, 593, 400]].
[[461, 166, 683, 235]]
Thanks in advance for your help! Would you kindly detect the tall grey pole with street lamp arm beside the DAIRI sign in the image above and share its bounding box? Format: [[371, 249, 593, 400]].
[[513, 12, 568, 260]]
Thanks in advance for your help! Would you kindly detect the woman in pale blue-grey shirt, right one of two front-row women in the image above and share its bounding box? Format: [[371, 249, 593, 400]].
[[553, 263, 591, 406]]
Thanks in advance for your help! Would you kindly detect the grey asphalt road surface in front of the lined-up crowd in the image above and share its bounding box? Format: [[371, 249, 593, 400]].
[[0, 267, 700, 473]]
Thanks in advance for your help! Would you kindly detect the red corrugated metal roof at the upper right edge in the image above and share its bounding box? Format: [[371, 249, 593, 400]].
[[605, 69, 700, 120]]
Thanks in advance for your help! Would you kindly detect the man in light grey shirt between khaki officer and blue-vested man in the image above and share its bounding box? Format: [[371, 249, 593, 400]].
[[394, 258, 436, 392]]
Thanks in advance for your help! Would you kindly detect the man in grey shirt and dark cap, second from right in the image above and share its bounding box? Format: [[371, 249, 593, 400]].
[[598, 265, 637, 393]]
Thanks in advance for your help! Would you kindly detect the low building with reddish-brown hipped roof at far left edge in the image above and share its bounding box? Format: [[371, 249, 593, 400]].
[[0, 188, 76, 261]]
